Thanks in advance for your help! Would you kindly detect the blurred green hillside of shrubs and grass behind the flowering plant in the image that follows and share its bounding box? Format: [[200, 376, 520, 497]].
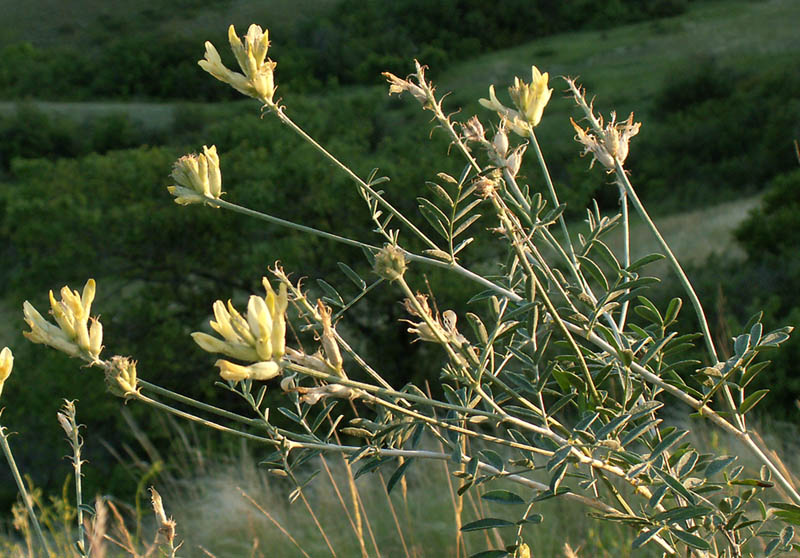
[[0, 0, 800, 552]]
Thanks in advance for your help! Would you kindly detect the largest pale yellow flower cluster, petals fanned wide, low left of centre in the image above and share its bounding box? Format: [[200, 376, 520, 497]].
[[192, 277, 289, 372]]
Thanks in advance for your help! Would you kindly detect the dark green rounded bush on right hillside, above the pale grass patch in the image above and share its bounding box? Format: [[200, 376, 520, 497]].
[[628, 60, 800, 210]]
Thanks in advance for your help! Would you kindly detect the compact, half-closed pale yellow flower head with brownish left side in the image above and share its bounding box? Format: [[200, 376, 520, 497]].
[[167, 145, 222, 205]]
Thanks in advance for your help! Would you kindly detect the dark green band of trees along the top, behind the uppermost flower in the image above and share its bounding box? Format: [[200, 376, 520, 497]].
[[0, 0, 687, 100]]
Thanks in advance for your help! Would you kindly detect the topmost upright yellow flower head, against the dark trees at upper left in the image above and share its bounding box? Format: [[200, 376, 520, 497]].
[[198, 24, 277, 103]]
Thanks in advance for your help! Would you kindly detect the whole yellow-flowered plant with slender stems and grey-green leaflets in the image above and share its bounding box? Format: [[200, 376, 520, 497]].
[[0, 25, 800, 557]]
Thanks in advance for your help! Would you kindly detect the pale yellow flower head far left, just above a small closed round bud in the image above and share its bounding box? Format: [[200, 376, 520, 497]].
[[23, 279, 103, 360]]
